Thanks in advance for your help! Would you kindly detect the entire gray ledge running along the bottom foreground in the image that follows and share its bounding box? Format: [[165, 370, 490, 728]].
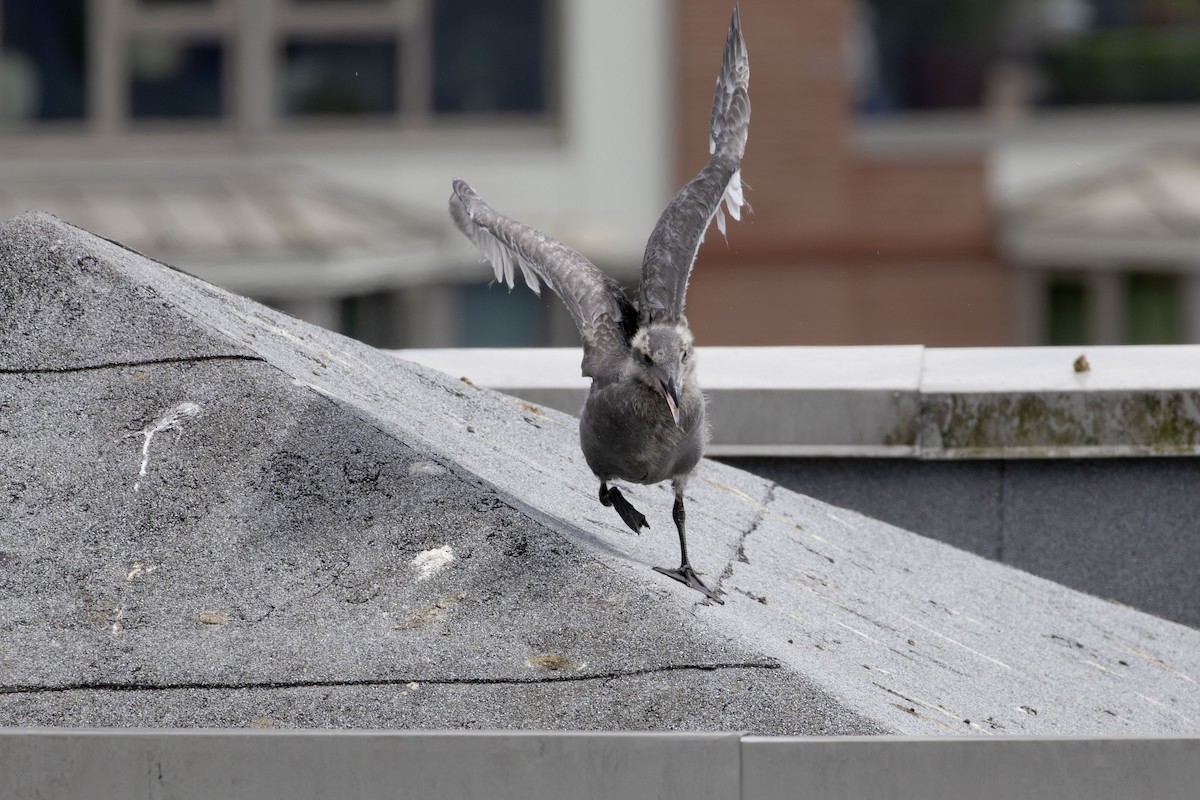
[[0, 729, 1200, 800]]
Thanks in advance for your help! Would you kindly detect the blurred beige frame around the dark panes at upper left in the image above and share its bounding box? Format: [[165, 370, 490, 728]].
[[0, 0, 562, 146]]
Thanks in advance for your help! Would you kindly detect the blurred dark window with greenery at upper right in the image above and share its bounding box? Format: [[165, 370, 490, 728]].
[[853, 0, 1200, 114]]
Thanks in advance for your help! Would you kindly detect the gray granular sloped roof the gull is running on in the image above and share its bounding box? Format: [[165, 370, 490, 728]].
[[0, 209, 1200, 734]]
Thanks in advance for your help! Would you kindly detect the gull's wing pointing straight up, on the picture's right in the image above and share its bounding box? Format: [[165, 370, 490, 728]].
[[638, 7, 750, 325]]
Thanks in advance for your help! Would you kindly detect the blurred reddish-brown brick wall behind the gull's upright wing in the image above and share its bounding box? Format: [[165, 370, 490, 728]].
[[674, 0, 1014, 345]]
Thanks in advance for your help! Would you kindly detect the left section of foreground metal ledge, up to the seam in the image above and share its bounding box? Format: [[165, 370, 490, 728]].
[[0, 729, 743, 800]]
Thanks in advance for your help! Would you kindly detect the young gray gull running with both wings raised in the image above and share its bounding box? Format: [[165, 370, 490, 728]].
[[450, 8, 750, 602]]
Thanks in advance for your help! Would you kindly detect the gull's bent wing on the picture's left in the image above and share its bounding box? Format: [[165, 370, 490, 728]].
[[450, 180, 636, 378]]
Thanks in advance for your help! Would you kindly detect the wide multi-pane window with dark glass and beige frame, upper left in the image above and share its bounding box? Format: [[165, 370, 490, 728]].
[[0, 0, 554, 134]]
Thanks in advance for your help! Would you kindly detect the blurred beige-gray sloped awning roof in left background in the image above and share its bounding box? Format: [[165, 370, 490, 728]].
[[0, 158, 444, 300]]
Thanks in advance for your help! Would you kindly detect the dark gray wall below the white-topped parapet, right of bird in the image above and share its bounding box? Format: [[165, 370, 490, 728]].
[[721, 457, 1200, 628]]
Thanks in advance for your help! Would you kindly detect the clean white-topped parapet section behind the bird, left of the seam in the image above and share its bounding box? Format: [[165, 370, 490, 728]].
[[395, 345, 924, 456]]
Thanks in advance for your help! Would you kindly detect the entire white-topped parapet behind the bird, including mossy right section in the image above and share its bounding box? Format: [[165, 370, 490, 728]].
[[397, 345, 1200, 459]]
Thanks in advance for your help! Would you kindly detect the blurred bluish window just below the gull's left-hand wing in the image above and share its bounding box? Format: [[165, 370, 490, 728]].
[[455, 278, 550, 347]]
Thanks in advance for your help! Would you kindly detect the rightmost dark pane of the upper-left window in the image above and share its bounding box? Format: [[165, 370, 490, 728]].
[[433, 0, 547, 114]]
